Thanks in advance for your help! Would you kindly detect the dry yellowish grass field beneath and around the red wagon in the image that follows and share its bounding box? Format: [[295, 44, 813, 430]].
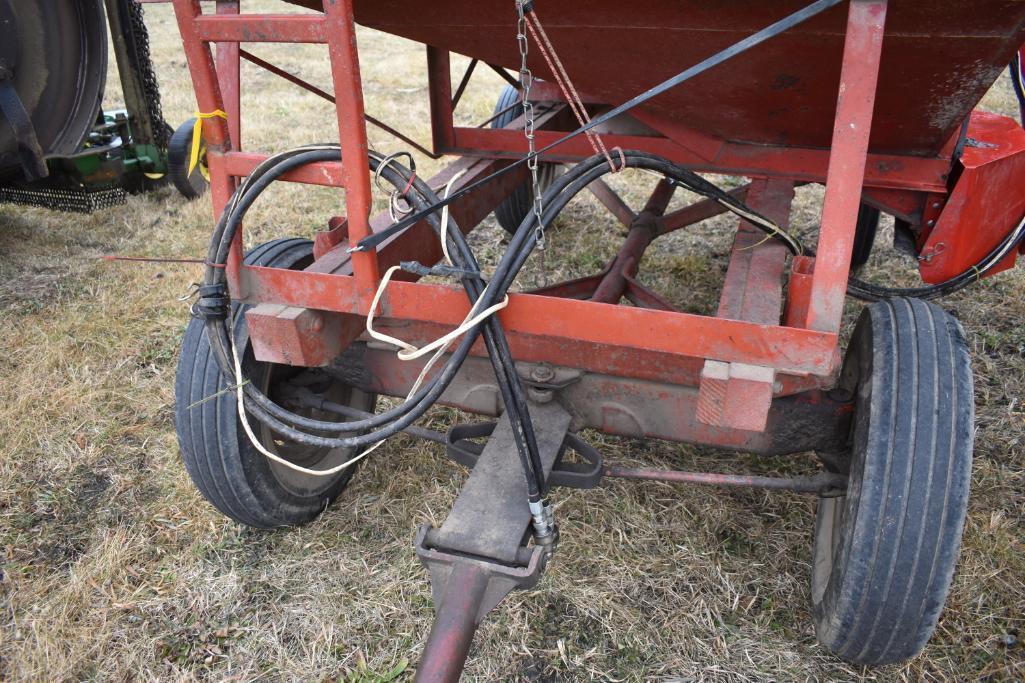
[[0, 3, 1025, 681]]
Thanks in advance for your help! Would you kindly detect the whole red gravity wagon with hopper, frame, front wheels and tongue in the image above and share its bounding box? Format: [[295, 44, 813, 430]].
[[164, 0, 1025, 681]]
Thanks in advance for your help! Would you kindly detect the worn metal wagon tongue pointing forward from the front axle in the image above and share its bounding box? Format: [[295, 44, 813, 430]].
[[416, 402, 570, 681]]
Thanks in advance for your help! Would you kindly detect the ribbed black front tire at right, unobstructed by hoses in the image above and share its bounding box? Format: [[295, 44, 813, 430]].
[[812, 298, 975, 666]]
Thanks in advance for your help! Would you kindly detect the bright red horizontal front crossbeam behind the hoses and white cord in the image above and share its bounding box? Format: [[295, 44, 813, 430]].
[[237, 267, 837, 376]]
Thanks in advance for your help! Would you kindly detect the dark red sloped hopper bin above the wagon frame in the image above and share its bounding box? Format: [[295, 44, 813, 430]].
[[342, 0, 1025, 157]]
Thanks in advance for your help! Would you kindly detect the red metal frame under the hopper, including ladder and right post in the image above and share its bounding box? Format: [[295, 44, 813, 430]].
[[173, 0, 1020, 436]]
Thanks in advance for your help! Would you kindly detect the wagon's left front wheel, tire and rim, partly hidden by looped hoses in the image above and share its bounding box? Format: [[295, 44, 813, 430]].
[[174, 239, 376, 529]]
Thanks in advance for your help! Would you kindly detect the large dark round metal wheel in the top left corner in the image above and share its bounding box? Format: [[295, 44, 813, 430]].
[[0, 0, 107, 178]]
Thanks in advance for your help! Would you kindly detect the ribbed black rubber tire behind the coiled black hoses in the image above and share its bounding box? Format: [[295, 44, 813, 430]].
[[174, 239, 376, 529]]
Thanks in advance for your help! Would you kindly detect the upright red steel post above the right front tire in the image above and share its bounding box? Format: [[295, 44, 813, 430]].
[[804, 0, 888, 332]]
